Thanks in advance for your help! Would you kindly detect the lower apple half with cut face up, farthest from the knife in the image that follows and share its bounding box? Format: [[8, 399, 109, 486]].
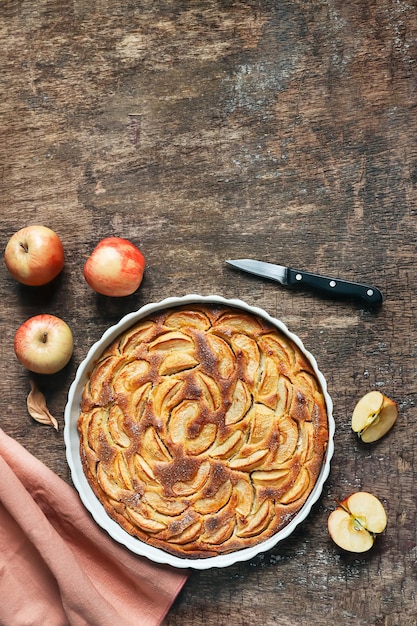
[[327, 491, 387, 552]]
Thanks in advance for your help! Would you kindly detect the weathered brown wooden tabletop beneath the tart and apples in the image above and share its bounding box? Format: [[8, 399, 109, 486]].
[[0, 0, 417, 626]]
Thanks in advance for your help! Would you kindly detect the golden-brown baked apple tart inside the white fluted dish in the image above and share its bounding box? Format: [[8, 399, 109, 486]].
[[78, 304, 328, 558]]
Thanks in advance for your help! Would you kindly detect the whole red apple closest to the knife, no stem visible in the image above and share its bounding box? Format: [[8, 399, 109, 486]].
[[84, 237, 145, 297]]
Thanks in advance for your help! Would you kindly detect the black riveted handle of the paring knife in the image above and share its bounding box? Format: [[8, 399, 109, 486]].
[[287, 267, 383, 305]]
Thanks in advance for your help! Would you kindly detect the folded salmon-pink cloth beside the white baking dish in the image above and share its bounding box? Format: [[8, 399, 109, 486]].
[[0, 429, 187, 626]]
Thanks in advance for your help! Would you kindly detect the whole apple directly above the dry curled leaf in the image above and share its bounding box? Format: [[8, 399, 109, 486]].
[[14, 313, 74, 374]]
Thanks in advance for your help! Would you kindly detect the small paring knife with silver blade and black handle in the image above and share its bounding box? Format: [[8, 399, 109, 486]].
[[226, 259, 383, 305]]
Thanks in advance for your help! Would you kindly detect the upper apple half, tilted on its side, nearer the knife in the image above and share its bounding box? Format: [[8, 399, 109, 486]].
[[352, 391, 398, 443]]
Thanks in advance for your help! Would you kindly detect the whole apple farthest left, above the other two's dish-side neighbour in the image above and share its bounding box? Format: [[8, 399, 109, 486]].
[[4, 224, 65, 287]]
